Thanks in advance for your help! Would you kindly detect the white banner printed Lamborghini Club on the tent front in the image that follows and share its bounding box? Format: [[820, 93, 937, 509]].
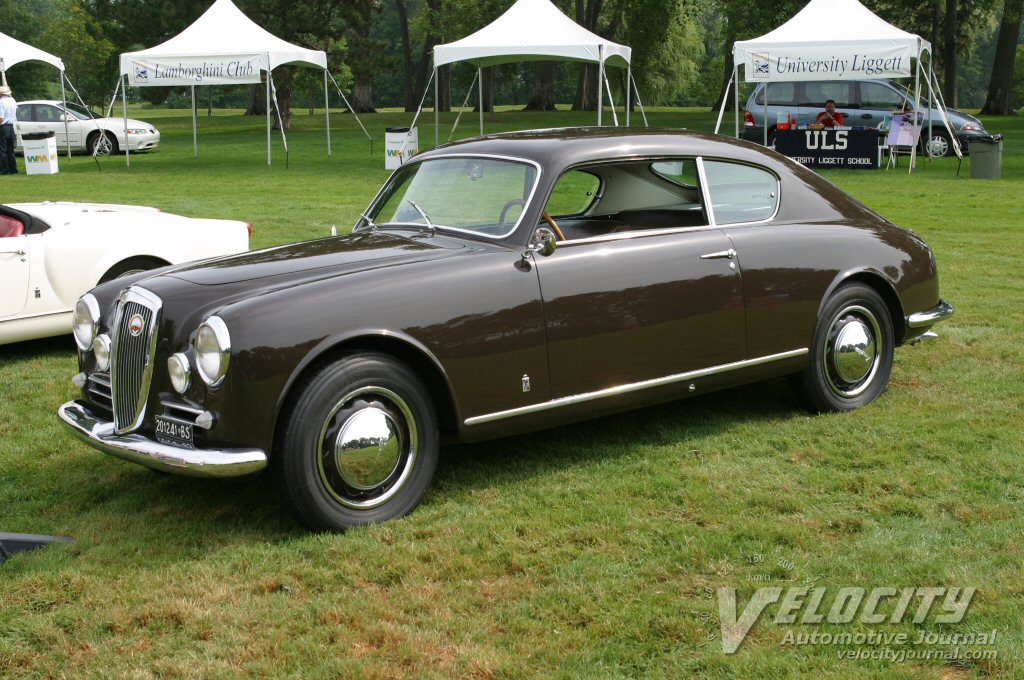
[[128, 54, 266, 87]]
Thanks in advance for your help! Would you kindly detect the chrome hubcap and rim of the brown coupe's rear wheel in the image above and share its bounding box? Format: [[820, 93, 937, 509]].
[[824, 305, 882, 397]]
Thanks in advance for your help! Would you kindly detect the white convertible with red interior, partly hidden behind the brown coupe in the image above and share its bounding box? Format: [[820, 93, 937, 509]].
[[0, 203, 252, 344]]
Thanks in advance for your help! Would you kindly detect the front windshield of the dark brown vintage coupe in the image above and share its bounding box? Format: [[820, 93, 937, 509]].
[[364, 157, 539, 238]]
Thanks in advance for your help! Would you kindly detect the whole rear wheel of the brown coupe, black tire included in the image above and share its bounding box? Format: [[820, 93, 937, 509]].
[[792, 284, 895, 413]]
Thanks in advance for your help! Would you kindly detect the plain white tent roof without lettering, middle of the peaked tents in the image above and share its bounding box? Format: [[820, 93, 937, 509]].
[[434, 0, 632, 68]]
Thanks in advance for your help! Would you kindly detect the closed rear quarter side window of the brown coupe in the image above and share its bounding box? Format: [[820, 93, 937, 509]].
[[703, 160, 778, 224]]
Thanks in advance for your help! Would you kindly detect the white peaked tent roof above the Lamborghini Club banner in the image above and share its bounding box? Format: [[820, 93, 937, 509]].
[[121, 0, 327, 75]]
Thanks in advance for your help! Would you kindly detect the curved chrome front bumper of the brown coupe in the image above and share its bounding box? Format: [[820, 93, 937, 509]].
[[57, 401, 266, 477]]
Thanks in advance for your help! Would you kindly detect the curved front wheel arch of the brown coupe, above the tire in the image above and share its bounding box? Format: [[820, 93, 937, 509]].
[[274, 333, 459, 446]]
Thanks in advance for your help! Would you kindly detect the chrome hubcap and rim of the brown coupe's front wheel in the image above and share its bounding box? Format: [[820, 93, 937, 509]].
[[318, 387, 418, 510]]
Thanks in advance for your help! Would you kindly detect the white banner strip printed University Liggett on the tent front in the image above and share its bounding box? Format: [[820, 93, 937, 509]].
[[744, 45, 912, 82]]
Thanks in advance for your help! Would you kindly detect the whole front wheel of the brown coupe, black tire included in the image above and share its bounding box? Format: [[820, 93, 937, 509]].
[[273, 352, 439, 532]]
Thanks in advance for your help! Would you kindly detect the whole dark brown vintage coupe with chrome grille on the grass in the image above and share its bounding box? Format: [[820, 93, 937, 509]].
[[59, 129, 952, 529]]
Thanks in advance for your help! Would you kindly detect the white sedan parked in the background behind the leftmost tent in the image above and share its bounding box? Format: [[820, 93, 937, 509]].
[[16, 100, 160, 156]]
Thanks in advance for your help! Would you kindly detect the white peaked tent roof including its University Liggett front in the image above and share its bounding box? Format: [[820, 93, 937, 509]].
[[733, 0, 931, 81]]
